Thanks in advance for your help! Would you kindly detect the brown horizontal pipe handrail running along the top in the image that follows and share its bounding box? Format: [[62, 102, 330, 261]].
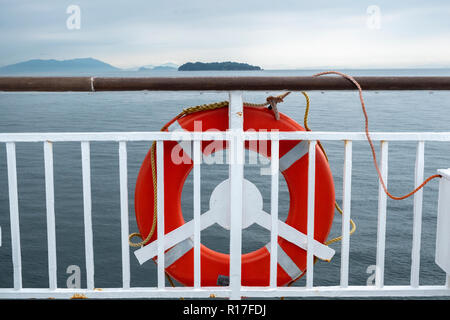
[[0, 76, 450, 92]]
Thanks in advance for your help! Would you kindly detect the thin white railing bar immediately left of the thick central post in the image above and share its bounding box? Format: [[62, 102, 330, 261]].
[[193, 140, 201, 288]]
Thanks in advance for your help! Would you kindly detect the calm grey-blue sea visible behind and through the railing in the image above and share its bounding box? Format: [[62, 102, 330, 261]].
[[0, 69, 450, 288]]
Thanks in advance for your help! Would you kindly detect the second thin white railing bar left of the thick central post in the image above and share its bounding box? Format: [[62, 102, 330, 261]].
[[156, 140, 165, 289]]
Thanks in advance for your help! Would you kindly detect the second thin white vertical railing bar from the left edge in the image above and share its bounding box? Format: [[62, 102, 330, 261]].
[[44, 141, 57, 290]]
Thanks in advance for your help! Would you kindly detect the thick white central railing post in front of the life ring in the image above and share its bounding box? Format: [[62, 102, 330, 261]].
[[228, 92, 244, 300]]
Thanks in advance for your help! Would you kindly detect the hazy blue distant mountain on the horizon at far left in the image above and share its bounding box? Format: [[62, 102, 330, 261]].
[[0, 58, 120, 74]]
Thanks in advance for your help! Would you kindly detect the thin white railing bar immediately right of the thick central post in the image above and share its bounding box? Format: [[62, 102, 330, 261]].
[[270, 139, 280, 289]]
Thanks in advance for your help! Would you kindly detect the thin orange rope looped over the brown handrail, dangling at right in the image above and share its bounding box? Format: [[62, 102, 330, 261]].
[[313, 71, 442, 200]]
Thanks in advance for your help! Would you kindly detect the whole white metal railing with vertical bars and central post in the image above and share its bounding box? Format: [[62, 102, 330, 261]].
[[0, 92, 450, 299]]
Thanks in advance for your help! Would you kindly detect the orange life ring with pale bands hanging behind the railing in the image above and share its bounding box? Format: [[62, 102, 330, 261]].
[[135, 106, 335, 286]]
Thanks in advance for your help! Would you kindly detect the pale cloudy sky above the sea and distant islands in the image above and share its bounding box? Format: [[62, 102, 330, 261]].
[[0, 0, 450, 69]]
